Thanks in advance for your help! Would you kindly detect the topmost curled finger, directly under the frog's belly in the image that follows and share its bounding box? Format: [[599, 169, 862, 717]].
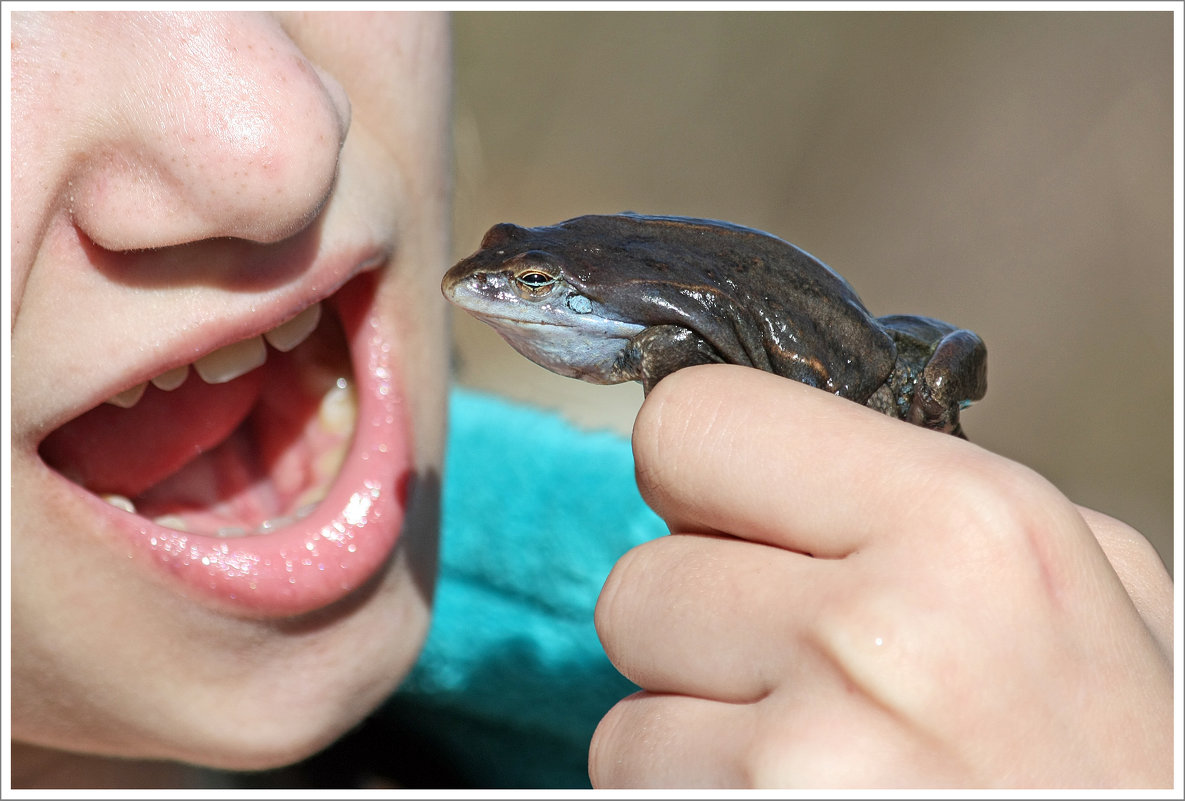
[[634, 365, 1052, 558]]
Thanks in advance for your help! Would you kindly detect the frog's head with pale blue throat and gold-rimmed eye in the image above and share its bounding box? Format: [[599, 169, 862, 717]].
[[441, 223, 642, 383]]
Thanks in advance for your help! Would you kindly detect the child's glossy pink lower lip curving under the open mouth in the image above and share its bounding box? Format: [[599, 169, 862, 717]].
[[68, 273, 411, 617]]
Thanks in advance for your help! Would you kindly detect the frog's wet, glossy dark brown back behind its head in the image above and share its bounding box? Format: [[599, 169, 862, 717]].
[[552, 213, 896, 403]]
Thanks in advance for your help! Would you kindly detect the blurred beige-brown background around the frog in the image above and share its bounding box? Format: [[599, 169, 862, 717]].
[[445, 11, 1173, 566]]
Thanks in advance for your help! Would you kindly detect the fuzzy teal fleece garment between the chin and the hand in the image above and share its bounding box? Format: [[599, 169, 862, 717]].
[[382, 390, 667, 788]]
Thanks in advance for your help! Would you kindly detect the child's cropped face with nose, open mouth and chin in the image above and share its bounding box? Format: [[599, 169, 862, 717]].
[[9, 12, 448, 768]]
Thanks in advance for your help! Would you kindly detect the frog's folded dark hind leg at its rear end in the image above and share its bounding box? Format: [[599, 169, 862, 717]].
[[908, 329, 987, 440]]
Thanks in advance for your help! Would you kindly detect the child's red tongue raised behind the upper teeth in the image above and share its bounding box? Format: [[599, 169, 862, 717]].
[[40, 369, 267, 498]]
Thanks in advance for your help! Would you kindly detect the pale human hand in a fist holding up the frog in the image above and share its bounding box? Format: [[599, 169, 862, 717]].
[[589, 365, 1173, 788]]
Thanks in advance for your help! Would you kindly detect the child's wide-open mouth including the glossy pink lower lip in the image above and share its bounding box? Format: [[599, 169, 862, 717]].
[[40, 271, 410, 616]]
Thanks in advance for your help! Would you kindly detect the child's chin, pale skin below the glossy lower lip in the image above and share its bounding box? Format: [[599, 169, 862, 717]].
[[12, 469, 436, 771]]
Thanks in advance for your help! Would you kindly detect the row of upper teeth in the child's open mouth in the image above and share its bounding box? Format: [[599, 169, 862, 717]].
[[107, 303, 321, 409]]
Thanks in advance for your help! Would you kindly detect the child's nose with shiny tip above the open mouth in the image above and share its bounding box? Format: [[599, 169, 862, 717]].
[[66, 12, 350, 250]]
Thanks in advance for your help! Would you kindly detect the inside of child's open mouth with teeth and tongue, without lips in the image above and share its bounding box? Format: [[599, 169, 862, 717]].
[[40, 283, 357, 538]]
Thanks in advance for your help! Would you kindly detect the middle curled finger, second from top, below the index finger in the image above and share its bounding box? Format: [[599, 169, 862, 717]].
[[595, 534, 838, 703]]
